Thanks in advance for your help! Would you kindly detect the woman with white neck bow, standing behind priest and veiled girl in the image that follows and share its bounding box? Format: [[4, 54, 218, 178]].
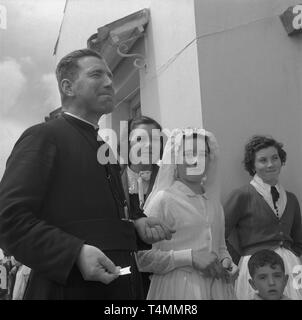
[[121, 116, 163, 297]]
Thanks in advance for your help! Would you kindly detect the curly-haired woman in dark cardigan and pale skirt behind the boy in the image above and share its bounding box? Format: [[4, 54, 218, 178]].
[[224, 136, 302, 300]]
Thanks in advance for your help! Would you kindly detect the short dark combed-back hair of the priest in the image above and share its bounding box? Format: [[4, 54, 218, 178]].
[[56, 49, 104, 98]]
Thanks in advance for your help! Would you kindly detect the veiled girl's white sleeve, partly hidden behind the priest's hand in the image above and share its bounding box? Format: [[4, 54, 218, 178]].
[[137, 191, 192, 274]]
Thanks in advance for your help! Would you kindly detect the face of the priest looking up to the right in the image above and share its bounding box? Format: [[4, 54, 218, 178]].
[[72, 56, 114, 117]]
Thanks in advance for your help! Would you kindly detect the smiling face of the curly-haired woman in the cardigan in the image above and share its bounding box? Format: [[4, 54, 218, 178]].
[[254, 147, 282, 185]]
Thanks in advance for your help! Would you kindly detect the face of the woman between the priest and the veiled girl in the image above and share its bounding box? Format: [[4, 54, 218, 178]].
[[129, 124, 161, 164]]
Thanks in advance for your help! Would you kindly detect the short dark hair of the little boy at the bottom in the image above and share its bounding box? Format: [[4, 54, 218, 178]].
[[247, 249, 285, 278]]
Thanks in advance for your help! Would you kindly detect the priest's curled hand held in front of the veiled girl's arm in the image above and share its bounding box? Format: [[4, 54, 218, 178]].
[[134, 217, 175, 244]]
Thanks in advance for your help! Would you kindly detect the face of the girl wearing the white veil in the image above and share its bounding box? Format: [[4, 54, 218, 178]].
[[177, 136, 209, 183]]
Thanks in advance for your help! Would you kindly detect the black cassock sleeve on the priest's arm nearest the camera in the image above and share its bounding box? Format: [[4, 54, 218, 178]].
[[0, 125, 84, 283]]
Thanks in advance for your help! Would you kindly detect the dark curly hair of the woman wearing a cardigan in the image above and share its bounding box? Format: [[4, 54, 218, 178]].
[[243, 135, 286, 176]]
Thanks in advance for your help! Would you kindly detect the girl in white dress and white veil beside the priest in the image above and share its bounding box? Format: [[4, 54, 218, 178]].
[[137, 129, 237, 300]]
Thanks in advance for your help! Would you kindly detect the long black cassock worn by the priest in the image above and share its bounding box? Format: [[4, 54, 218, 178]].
[[0, 114, 141, 299]]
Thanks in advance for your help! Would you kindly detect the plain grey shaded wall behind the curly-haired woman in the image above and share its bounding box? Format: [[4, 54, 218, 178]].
[[195, 0, 302, 201]]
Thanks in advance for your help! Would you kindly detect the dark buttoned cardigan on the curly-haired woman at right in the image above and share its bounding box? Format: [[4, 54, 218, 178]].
[[224, 184, 302, 256]]
